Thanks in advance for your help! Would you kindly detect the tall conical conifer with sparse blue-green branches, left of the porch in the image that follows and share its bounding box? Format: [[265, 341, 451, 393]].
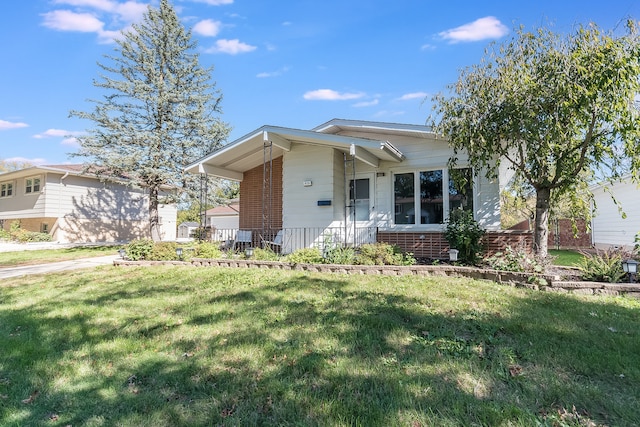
[[71, 0, 229, 241]]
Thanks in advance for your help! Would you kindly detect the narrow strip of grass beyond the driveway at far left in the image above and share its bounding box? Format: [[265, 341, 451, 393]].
[[0, 246, 118, 268]]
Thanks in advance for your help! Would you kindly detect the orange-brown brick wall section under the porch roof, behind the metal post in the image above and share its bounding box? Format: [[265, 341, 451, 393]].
[[239, 156, 282, 230]]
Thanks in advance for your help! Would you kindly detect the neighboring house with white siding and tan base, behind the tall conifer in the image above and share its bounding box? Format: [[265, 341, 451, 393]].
[[0, 165, 177, 243]]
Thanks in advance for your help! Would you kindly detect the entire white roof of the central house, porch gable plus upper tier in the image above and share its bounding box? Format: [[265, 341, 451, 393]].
[[185, 119, 434, 181]]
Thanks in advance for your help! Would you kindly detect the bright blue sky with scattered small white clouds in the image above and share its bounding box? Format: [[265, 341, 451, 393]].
[[0, 0, 640, 164]]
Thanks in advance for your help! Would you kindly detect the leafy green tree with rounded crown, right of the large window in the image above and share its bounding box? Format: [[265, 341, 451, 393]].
[[433, 21, 640, 257]]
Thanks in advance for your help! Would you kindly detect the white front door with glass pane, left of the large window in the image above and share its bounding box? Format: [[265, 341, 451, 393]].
[[346, 174, 375, 246]]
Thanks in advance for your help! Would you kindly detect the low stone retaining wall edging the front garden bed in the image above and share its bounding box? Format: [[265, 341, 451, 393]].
[[114, 258, 640, 298]]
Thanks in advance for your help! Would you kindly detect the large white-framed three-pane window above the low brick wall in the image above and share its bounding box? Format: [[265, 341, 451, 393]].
[[393, 168, 473, 225]]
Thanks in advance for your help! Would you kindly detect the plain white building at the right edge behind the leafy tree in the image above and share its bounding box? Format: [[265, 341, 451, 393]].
[[591, 176, 640, 249]]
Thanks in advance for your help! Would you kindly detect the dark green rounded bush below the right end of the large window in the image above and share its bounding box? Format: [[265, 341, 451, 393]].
[[444, 209, 485, 264]]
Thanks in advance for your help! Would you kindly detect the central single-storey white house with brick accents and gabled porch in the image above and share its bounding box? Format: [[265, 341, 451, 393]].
[[186, 119, 530, 258]]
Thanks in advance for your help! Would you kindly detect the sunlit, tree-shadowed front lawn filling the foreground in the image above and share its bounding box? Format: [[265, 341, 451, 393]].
[[0, 266, 640, 427]]
